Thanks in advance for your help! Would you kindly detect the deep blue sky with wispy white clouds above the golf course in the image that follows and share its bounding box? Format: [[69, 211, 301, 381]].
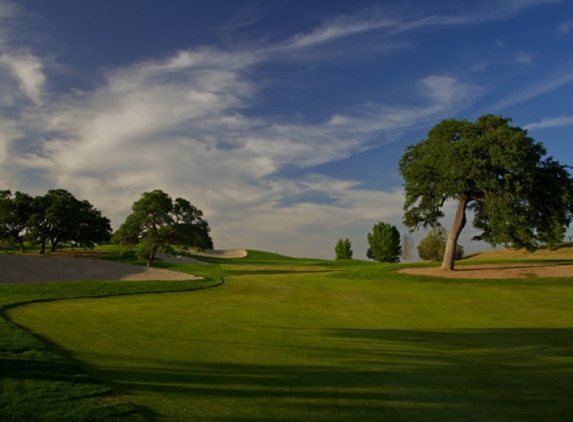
[[0, 0, 573, 259]]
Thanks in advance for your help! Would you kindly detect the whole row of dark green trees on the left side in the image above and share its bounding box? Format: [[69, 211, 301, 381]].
[[0, 189, 213, 265]]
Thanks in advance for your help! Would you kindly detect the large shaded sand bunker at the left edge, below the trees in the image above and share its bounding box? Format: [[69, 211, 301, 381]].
[[0, 254, 200, 284]]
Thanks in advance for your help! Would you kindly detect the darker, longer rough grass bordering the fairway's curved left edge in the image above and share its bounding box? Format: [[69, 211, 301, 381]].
[[0, 258, 219, 422]]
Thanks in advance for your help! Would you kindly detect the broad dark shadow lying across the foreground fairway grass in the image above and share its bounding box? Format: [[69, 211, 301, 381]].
[[32, 328, 573, 421]]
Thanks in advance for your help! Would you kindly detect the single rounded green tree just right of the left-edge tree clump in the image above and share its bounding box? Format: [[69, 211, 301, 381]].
[[114, 190, 213, 266]]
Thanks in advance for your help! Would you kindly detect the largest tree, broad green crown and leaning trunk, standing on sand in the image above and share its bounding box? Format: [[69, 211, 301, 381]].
[[400, 115, 573, 270]]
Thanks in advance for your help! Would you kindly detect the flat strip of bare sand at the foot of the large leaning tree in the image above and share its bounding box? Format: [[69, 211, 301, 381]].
[[398, 264, 573, 279]]
